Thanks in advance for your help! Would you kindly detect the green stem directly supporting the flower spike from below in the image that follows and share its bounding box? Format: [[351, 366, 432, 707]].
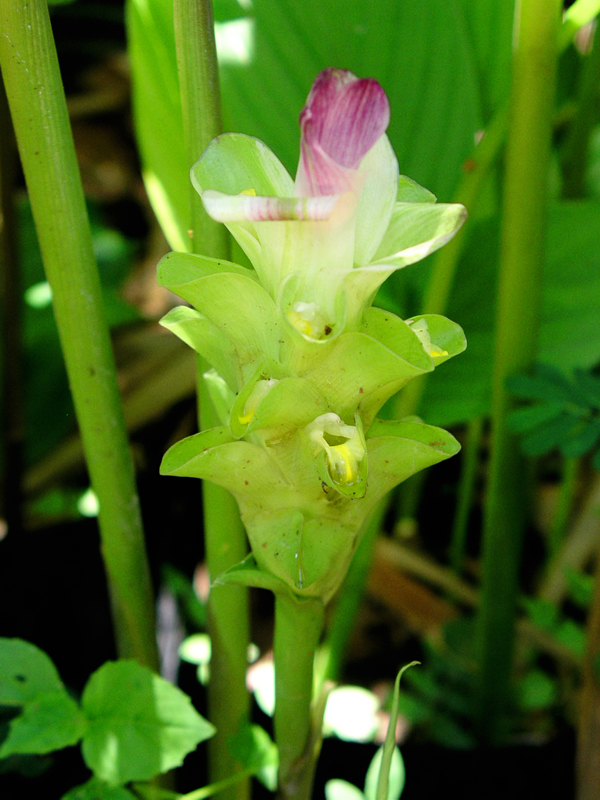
[[274, 594, 324, 800]]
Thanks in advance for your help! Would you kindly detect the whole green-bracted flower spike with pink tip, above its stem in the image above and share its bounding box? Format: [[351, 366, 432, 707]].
[[159, 70, 466, 600]]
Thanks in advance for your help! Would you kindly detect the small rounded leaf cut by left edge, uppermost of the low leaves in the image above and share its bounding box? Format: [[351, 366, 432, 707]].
[[0, 638, 65, 706]]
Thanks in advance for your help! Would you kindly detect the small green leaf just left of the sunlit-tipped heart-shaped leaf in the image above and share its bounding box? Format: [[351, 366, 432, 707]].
[[0, 689, 86, 758]]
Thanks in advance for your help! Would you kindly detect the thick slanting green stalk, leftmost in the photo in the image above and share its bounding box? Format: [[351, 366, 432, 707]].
[[0, 0, 158, 669]]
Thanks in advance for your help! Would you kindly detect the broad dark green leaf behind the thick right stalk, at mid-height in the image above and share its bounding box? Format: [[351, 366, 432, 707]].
[[420, 202, 600, 425]]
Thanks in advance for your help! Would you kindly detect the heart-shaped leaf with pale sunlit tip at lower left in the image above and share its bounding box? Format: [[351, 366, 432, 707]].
[[82, 661, 215, 785]]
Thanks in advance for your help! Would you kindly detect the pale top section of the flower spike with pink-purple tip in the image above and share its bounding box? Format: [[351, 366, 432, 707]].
[[192, 69, 466, 342]]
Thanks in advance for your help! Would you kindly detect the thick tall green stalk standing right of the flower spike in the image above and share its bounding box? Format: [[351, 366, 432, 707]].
[[478, 0, 562, 741]]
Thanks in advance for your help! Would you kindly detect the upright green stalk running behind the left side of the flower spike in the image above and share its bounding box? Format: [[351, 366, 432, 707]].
[[173, 0, 250, 800]]
